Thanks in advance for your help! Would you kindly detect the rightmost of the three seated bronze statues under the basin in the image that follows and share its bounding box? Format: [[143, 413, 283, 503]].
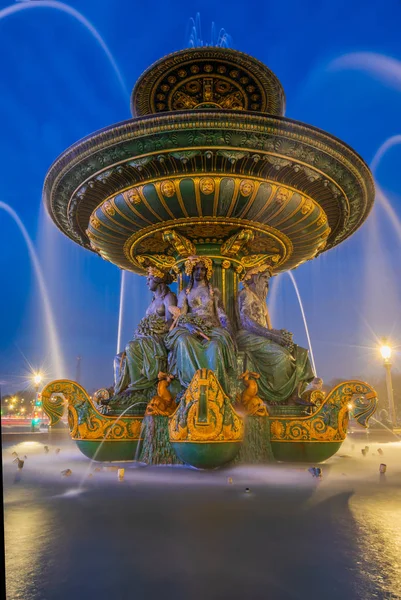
[[237, 265, 314, 404]]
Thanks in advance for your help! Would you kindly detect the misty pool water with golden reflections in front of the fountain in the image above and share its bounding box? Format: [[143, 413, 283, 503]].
[[3, 434, 401, 600]]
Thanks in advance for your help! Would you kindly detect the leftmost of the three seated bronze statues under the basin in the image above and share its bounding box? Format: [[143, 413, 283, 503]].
[[114, 267, 177, 395]]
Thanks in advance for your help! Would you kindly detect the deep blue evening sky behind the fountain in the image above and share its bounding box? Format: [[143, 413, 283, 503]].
[[0, 0, 401, 392]]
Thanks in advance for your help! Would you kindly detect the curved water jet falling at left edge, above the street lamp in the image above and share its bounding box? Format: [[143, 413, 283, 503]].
[[0, 201, 65, 379]]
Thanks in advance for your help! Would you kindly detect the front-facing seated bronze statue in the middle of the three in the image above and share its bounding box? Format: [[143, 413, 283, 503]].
[[166, 256, 236, 394]]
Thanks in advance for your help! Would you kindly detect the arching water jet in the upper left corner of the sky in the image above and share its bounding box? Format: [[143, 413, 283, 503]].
[[0, 0, 129, 96]]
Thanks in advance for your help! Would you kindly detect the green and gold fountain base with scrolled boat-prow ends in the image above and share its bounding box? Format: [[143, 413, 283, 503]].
[[42, 376, 377, 469]]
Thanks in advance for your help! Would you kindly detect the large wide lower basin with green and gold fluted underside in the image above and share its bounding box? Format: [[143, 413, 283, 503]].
[[44, 110, 374, 272]]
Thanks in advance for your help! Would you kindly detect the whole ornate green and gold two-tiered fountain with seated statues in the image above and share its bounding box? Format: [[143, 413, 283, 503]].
[[42, 47, 377, 468]]
